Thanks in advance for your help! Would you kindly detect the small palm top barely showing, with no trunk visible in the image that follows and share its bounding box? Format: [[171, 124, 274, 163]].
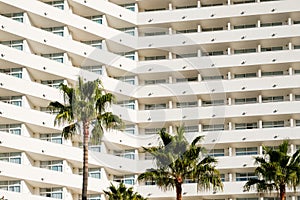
[[103, 183, 147, 200]]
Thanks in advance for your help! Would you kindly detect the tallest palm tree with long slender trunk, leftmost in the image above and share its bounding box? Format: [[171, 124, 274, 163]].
[[49, 78, 121, 200]]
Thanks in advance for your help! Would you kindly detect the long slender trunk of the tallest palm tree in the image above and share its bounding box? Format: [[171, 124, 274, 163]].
[[81, 121, 89, 200]]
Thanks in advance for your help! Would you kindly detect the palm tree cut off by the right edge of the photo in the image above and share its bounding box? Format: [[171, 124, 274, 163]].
[[244, 140, 300, 200]]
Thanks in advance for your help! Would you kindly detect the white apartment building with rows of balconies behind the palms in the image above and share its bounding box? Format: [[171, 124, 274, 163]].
[[0, 0, 300, 200]]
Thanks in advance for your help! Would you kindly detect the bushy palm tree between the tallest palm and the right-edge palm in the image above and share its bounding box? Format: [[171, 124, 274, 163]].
[[138, 126, 223, 200]]
